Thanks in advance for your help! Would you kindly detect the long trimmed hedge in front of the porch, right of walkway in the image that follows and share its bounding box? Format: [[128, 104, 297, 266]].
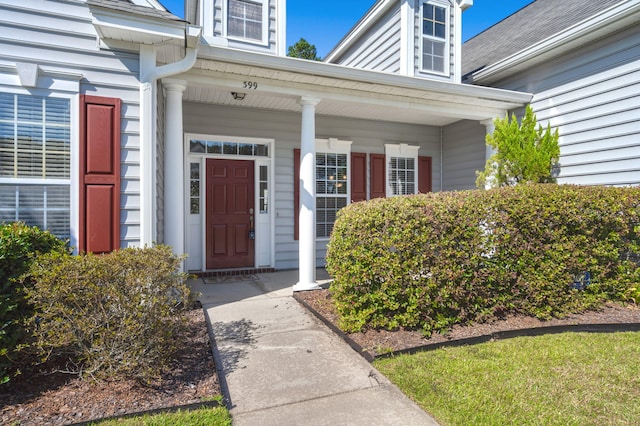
[[327, 185, 640, 333]]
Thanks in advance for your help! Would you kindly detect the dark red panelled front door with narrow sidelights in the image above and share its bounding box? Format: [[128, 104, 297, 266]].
[[206, 160, 255, 269]]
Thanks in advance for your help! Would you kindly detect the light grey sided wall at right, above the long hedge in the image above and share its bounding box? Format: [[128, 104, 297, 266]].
[[488, 26, 640, 185]]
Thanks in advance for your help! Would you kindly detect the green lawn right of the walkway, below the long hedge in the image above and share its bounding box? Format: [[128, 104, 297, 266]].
[[375, 332, 640, 425]]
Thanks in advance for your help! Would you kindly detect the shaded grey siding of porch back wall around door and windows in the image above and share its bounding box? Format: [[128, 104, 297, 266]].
[[184, 103, 440, 269]]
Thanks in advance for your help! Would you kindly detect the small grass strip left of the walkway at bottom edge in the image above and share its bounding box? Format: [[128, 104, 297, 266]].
[[92, 407, 231, 426]]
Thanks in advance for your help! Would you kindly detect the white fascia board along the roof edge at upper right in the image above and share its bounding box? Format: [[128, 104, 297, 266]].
[[471, 0, 640, 84]]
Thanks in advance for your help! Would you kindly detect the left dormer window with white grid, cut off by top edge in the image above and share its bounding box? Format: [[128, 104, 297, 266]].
[[227, 0, 268, 44]]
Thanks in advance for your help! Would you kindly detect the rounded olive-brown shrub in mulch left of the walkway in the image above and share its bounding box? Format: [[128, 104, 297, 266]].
[[28, 246, 189, 380]]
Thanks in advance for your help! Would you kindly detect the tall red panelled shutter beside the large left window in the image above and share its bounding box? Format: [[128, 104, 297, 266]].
[[78, 95, 121, 253]]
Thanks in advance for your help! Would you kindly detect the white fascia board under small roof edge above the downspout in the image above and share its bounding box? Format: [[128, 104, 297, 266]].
[[92, 8, 185, 43]]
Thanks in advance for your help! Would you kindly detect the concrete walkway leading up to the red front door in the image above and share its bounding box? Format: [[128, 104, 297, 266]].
[[191, 270, 436, 426]]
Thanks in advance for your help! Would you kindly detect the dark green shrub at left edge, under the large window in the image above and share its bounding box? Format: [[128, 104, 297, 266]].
[[0, 222, 67, 383]]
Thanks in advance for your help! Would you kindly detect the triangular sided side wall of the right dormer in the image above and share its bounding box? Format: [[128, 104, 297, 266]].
[[335, 2, 401, 74]]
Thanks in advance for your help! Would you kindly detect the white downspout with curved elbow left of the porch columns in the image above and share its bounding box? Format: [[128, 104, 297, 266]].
[[140, 24, 202, 246]]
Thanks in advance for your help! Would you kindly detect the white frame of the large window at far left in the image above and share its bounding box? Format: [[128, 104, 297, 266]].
[[0, 85, 80, 247]]
